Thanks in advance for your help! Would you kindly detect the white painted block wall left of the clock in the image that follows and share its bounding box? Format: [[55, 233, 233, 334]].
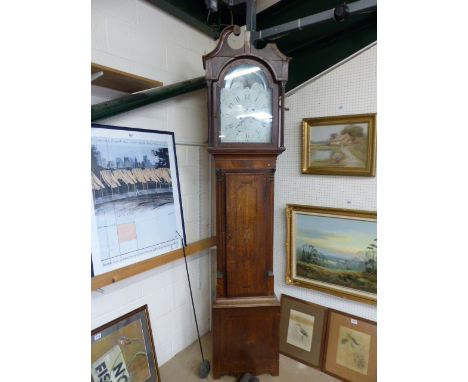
[[91, 0, 215, 365]]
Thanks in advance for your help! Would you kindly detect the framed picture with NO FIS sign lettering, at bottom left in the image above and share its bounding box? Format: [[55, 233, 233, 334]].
[[91, 305, 160, 382]]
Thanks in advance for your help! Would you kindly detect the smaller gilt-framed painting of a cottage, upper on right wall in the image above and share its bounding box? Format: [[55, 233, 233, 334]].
[[302, 114, 376, 176]]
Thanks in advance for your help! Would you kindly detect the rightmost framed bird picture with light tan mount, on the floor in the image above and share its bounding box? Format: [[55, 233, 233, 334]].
[[323, 310, 377, 382]]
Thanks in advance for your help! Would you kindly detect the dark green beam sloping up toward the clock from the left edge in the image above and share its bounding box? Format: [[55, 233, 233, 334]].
[[91, 77, 206, 122]]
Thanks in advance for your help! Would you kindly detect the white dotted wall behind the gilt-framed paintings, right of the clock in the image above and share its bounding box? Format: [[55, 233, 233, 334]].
[[274, 45, 378, 320]]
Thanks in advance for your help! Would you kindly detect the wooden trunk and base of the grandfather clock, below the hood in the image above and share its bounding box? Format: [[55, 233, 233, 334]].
[[212, 152, 280, 379]]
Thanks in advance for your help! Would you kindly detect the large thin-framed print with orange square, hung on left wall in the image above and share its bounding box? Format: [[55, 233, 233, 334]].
[[91, 124, 185, 277]]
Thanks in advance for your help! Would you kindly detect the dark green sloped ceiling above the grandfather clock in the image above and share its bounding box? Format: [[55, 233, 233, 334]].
[[147, 0, 377, 90]]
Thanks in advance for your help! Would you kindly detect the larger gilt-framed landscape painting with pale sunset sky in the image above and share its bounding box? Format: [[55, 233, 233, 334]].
[[286, 204, 377, 304]]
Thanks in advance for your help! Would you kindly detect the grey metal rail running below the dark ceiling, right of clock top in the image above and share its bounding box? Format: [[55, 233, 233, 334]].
[[252, 0, 377, 43]]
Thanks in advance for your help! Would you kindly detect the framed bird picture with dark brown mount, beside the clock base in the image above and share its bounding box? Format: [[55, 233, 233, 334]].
[[280, 294, 328, 368]]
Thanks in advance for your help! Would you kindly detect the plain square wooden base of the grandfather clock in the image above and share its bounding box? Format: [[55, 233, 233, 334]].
[[212, 297, 280, 379]]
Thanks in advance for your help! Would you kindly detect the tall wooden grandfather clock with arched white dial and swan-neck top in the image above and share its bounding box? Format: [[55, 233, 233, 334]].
[[203, 26, 289, 379]]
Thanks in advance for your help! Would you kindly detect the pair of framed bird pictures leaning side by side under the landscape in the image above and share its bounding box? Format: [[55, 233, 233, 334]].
[[280, 295, 377, 382]]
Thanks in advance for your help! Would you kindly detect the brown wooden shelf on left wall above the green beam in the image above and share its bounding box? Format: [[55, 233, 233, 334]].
[[91, 62, 163, 93]]
